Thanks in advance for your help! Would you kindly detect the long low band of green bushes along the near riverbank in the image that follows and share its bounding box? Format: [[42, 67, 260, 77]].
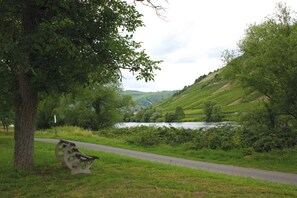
[[92, 118, 297, 155]]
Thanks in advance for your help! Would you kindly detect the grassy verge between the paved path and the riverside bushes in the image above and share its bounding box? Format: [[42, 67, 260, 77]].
[[32, 127, 297, 173]]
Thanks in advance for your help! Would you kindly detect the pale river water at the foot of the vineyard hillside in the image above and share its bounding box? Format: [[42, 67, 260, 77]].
[[116, 122, 230, 129]]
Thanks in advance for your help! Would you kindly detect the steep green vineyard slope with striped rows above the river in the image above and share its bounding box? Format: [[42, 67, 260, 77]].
[[155, 69, 260, 121]]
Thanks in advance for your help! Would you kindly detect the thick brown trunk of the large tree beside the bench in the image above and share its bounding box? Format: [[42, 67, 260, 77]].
[[14, 0, 38, 169]]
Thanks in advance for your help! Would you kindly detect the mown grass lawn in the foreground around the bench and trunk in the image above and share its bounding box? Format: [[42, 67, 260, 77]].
[[0, 136, 297, 198]]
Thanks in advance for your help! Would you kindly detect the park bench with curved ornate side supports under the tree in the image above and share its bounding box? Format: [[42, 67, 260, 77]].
[[55, 140, 99, 175]]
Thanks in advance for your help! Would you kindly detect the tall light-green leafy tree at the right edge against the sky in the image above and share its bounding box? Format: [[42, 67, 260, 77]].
[[233, 3, 297, 119]]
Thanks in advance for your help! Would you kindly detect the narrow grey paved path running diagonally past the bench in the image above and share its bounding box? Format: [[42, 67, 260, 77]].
[[35, 138, 297, 185]]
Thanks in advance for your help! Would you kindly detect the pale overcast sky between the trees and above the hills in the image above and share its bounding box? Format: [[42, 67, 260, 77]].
[[122, 0, 297, 92]]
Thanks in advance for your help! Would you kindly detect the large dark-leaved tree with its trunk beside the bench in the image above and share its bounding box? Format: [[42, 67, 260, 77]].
[[0, 0, 159, 168]]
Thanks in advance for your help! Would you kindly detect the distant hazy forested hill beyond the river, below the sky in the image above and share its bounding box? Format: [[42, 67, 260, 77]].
[[123, 90, 177, 110]]
